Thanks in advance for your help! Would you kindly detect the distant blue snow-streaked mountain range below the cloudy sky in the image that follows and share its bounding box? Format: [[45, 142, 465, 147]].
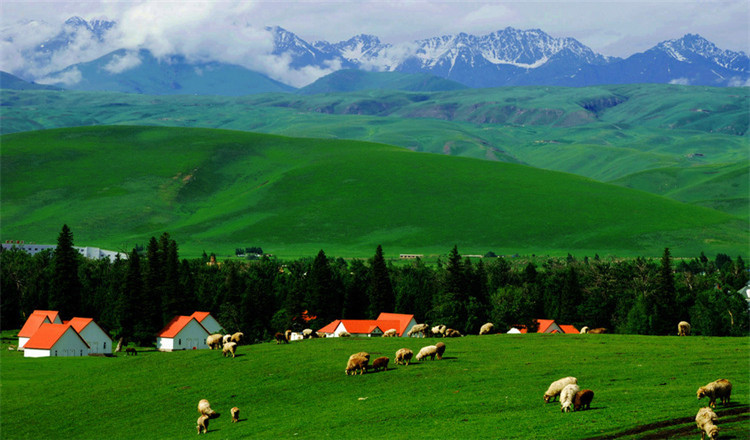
[[0, 17, 750, 95]]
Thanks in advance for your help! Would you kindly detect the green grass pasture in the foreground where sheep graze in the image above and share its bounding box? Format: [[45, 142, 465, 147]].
[[0, 332, 750, 440]]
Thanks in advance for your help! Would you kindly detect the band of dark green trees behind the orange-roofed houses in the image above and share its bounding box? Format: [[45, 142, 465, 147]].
[[0, 226, 750, 345]]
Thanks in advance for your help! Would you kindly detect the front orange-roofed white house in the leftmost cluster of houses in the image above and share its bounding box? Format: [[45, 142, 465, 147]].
[[23, 323, 90, 357]]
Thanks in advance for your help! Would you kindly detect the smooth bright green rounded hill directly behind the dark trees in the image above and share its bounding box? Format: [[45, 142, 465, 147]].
[[0, 126, 748, 257]]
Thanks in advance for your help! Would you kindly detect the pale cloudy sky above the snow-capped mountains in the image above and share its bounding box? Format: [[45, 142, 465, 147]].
[[0, 0, 750, 57]]
